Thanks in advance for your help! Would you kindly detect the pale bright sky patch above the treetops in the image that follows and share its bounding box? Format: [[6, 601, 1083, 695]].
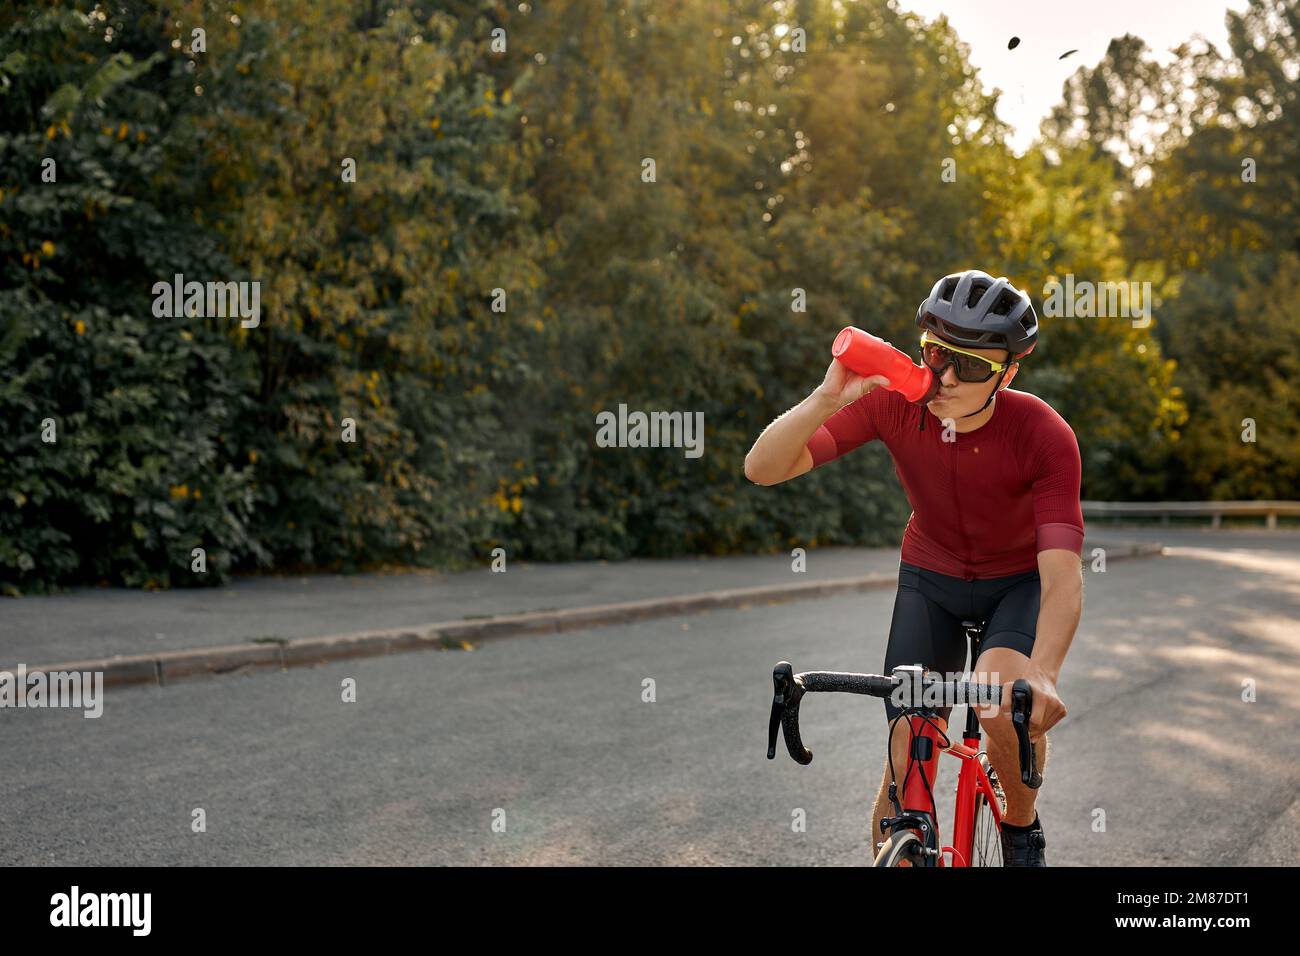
[[898, 0, 1245, 152]]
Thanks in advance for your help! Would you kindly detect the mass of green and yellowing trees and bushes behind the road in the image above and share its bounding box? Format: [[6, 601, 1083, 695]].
[[0, 0, 1300, 592]]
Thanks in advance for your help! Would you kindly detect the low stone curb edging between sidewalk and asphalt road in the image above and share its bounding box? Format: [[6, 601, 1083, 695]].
[[20, 544, 1164, 687]]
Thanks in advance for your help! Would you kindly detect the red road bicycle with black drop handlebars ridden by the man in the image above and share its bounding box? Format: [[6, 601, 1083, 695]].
[[767, 620, 1043, 866]]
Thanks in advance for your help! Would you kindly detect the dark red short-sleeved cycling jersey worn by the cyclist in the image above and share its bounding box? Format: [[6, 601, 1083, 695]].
[[807, 388, 1083, 581]]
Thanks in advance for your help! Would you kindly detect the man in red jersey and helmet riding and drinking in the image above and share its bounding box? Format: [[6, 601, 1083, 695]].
[[745, 269, 1083, 866]]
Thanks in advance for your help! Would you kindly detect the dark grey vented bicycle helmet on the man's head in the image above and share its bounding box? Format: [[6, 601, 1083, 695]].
[[917, 269, 1039, 362]]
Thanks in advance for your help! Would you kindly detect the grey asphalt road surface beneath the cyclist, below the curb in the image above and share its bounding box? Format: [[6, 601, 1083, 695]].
[[0, 531, 1300, 866]]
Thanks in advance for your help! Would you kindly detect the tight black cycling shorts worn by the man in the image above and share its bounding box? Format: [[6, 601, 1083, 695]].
[[881, 561, 1040, 722]]
